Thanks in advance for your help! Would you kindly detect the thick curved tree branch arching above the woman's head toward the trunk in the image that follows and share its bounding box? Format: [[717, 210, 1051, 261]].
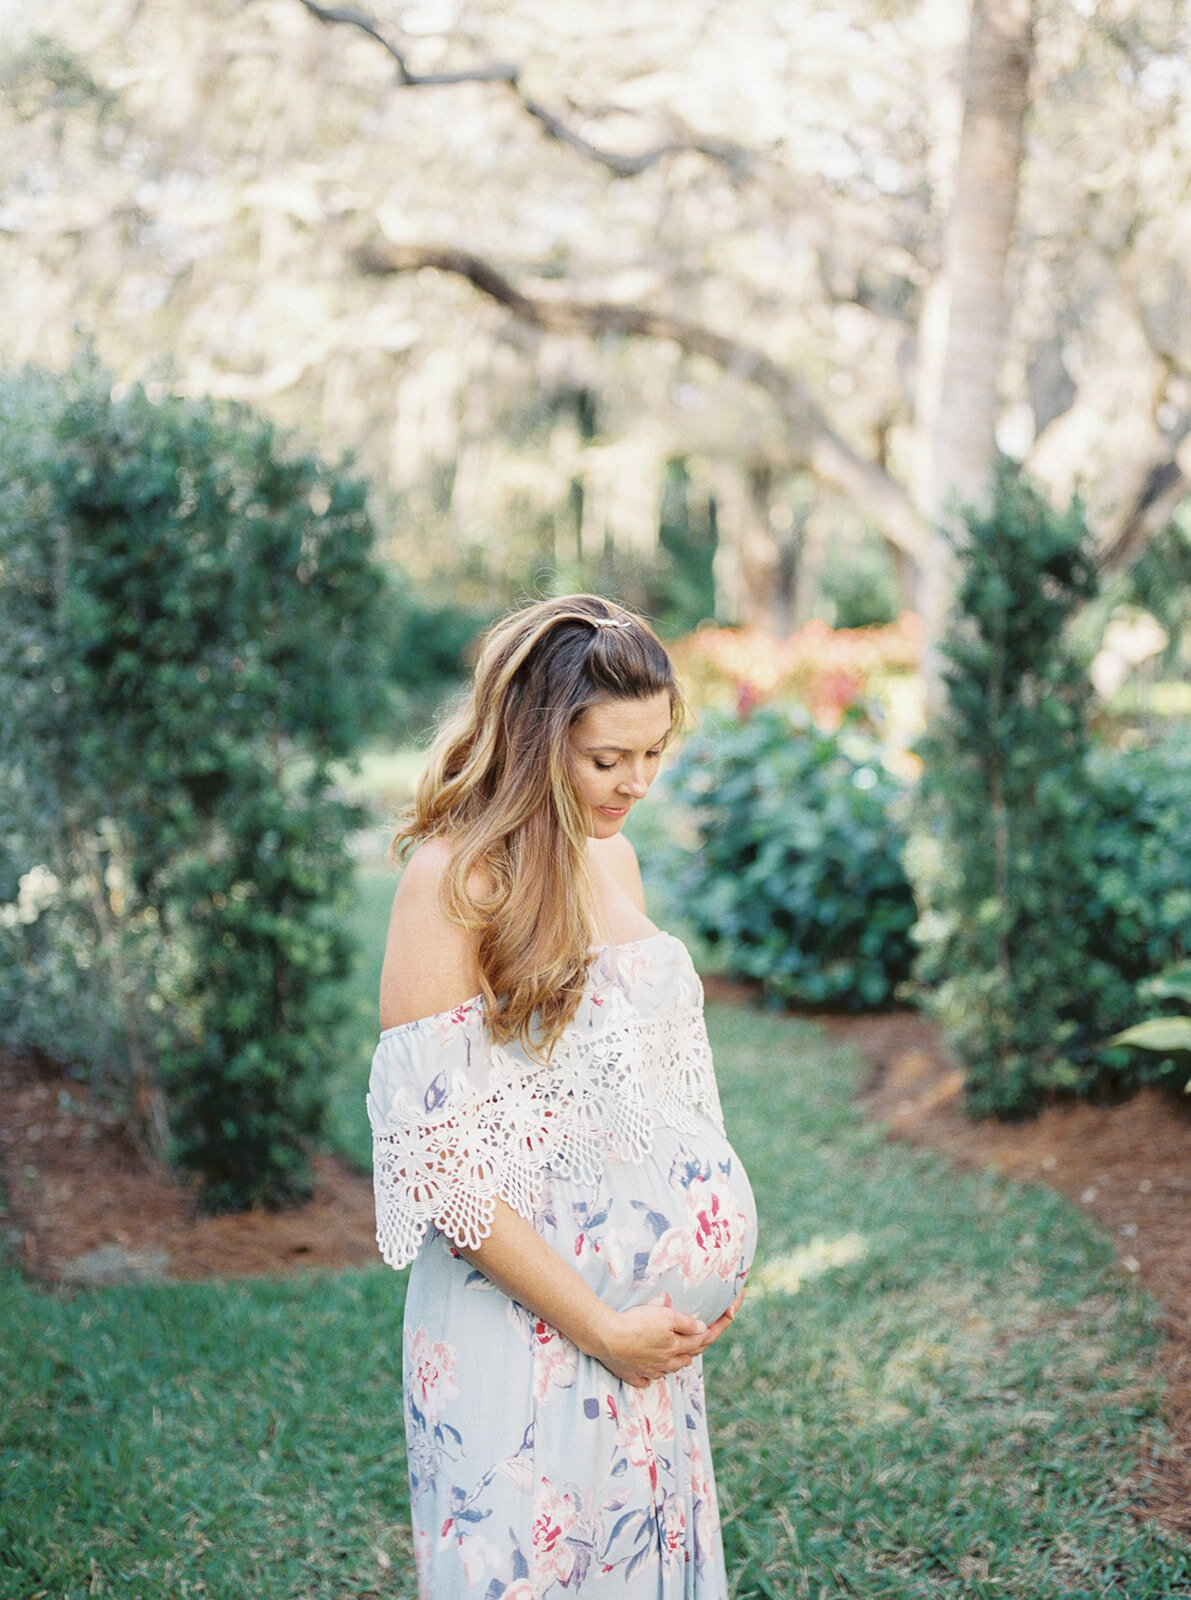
[[354, 243, 925, 562]]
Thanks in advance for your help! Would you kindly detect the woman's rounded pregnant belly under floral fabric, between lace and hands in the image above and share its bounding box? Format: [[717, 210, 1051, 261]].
[[538, 1123, 757, 1322]]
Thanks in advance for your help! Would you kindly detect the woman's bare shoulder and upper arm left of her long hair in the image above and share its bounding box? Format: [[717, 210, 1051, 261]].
[[381, 838, 480, 1027]]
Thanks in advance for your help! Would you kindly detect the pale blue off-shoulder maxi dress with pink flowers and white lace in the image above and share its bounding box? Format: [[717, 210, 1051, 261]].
[[368, 933, 756, 1600]]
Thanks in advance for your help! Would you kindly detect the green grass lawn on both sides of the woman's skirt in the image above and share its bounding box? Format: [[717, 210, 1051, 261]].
[[0, 1004, 1191, 1600]]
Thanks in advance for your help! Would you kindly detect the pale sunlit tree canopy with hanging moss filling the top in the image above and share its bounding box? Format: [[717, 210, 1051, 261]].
[[0, 0, 1191, 624]]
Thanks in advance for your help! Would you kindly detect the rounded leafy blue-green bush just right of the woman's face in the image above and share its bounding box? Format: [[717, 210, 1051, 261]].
[[666, 707, 917, 1011]]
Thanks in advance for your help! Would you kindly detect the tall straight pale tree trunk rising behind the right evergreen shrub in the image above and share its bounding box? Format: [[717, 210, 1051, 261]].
[[919, 0, 1034, 678]]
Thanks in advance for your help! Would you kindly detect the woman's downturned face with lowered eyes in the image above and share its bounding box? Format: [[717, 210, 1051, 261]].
[[570, 690, 671, 838]]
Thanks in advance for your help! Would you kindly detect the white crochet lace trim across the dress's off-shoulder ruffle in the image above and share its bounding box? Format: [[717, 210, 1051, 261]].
[[368, 992, 724, 1267]]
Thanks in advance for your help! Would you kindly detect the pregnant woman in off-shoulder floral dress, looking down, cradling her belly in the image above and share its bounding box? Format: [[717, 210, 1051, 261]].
[[368, 595, 756, 1600]]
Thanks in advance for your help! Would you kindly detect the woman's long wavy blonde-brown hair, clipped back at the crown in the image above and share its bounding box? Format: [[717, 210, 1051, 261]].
[[392, 595, 682, 1056]]
